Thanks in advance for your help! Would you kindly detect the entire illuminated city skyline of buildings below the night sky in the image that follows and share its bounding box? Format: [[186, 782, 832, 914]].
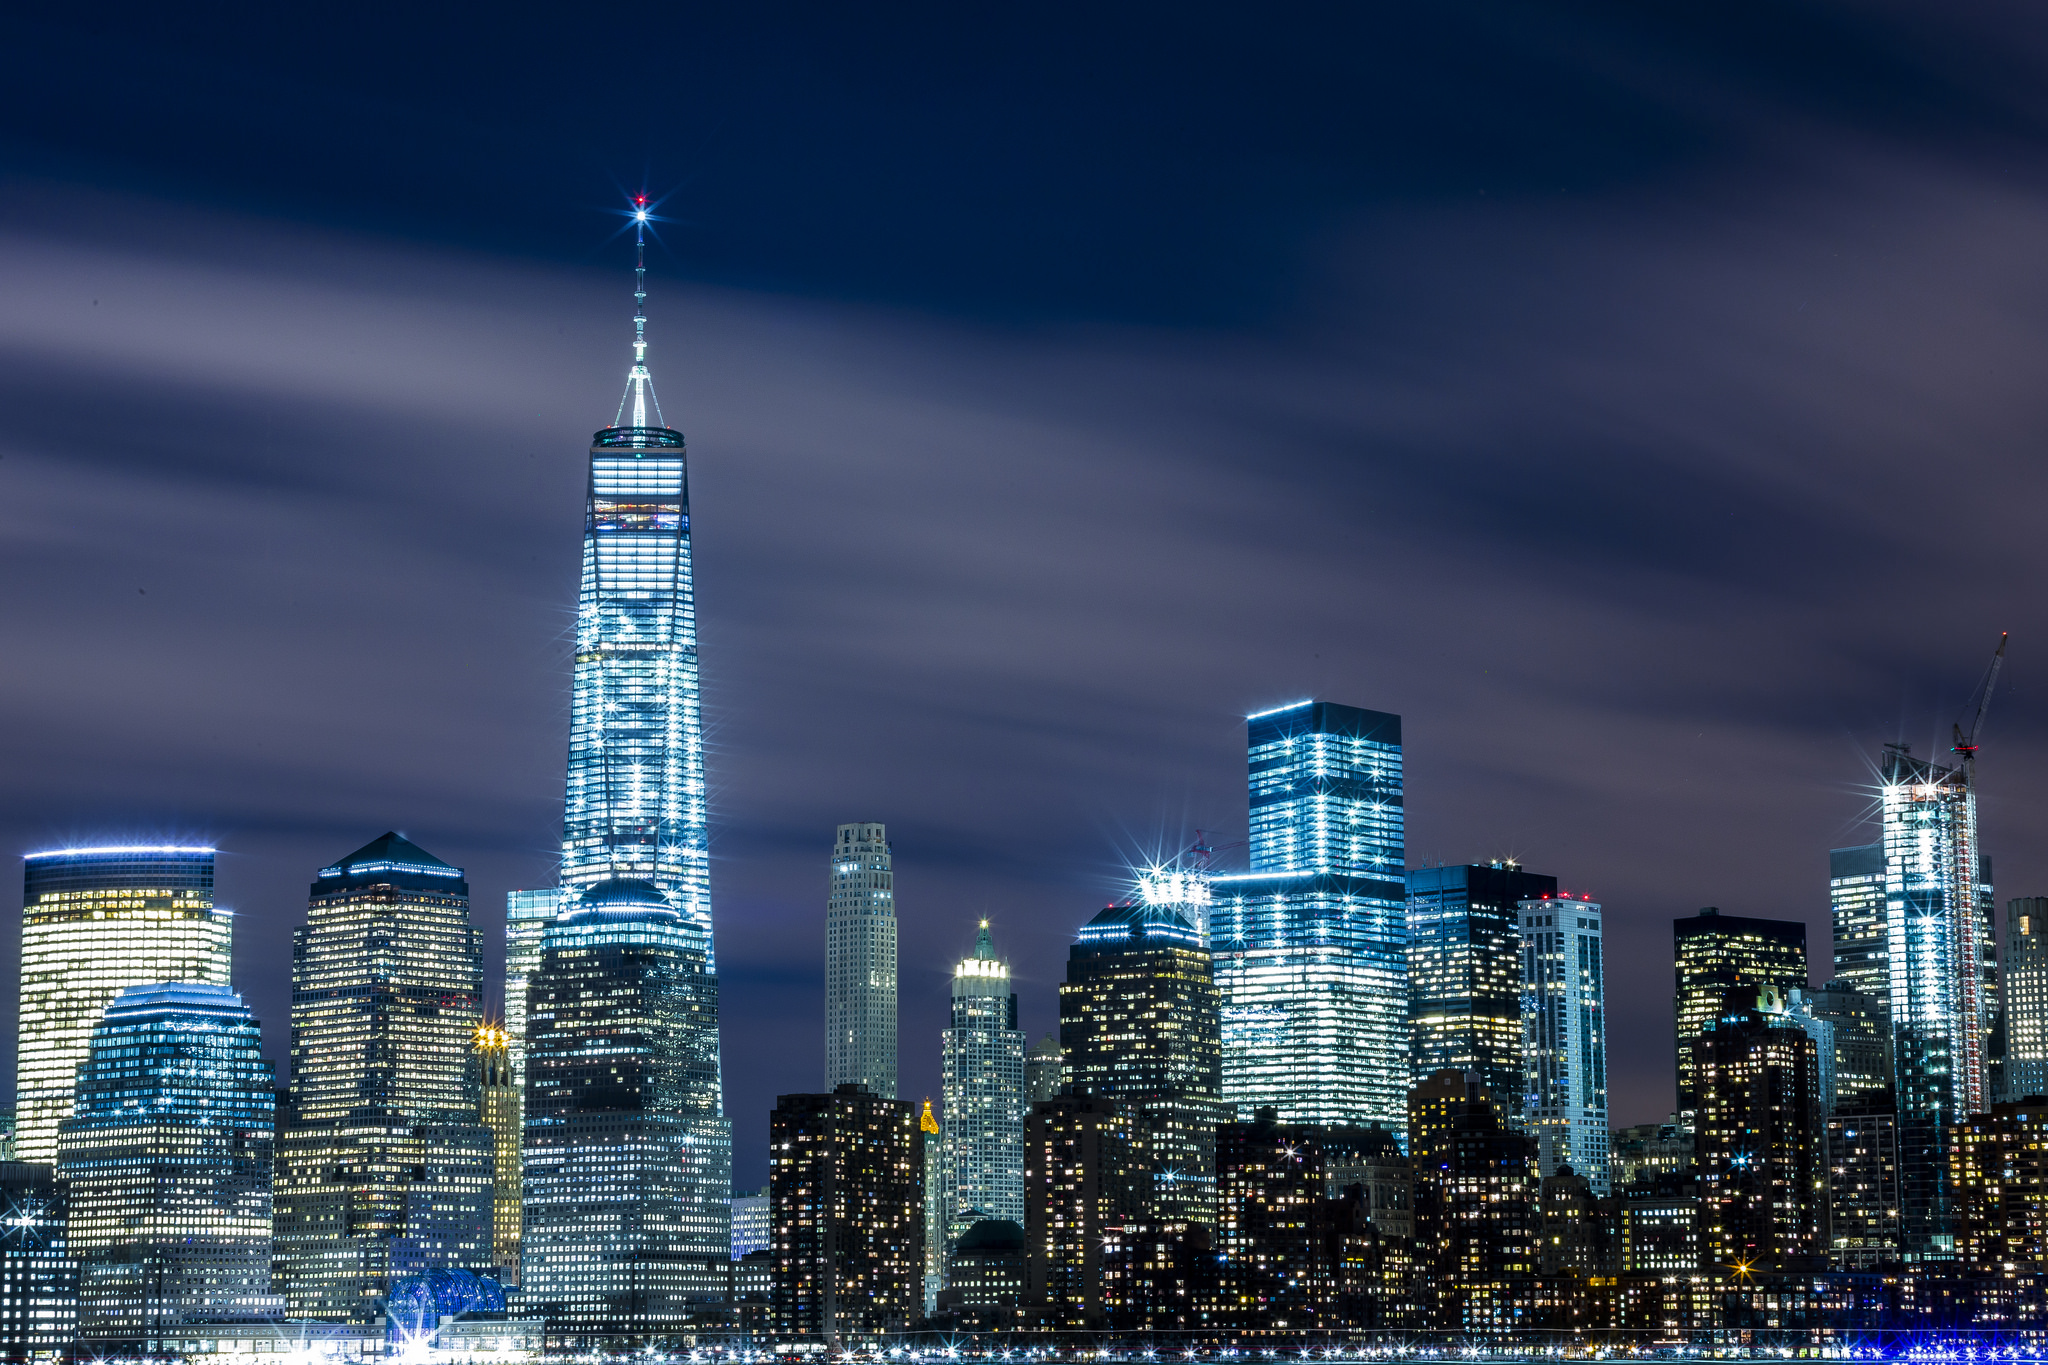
[[0, 240, 2048, 1361]]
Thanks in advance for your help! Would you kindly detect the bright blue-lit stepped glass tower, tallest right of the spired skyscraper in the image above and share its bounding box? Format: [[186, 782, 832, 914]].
[[1208, 700, 1409, 1134]]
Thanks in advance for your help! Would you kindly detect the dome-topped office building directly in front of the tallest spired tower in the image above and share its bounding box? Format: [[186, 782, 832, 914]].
[[520, 878, 731, 1349]]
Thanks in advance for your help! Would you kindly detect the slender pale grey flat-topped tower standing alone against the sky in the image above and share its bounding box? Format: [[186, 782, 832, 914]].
[[825, 825, 897, 1099]]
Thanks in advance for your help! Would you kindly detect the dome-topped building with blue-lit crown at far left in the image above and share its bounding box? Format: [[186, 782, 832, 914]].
[[57, 982, 281, 1353]]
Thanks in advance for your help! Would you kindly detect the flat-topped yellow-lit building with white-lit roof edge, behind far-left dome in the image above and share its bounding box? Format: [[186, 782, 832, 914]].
[[14, 845, 233, 1164]]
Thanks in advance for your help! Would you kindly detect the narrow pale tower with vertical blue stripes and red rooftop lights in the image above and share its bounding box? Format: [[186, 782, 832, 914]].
[[1518, 896, 1612, 1197]]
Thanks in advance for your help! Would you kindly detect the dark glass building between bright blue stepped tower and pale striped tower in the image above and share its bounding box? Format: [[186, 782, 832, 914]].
[[1407, 862, 1556, 1103]]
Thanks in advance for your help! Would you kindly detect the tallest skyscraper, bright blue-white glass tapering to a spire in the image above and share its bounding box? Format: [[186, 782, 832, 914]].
[[552, 224, 731, 1254]]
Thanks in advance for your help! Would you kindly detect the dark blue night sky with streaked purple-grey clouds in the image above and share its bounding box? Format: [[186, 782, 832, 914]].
[[0, 0, 2048, 1185]]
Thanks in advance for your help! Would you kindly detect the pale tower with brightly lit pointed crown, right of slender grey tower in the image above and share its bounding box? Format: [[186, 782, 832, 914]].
[[940, 919, 1024, 1242]]
